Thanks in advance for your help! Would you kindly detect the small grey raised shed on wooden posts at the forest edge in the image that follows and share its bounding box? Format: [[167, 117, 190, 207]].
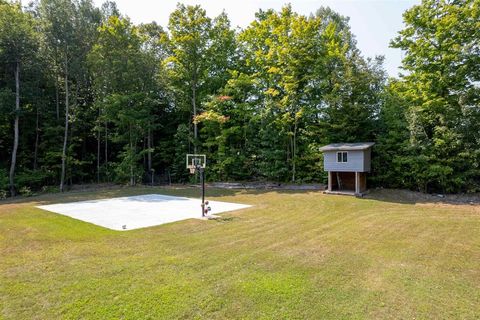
[[320, 142, 374, 195]]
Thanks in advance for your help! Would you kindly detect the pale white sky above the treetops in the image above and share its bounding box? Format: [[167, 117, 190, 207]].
[[94, 0, 420, 76]]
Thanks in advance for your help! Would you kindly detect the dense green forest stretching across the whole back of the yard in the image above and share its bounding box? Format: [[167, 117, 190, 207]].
[[0, 0, 480, 197]]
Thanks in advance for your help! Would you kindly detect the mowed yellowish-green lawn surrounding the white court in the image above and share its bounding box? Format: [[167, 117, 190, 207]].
[[0, 188, 480, 319]]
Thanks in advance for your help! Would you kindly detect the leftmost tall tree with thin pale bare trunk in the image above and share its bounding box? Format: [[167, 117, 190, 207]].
[[0, 2, 37, 196]]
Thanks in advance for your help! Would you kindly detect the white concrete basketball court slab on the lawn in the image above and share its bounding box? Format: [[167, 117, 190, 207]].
[[37, 194, 251, 231]]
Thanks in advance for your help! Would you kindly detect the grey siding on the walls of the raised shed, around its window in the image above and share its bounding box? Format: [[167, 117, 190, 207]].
[[323, 149, 371, 172]]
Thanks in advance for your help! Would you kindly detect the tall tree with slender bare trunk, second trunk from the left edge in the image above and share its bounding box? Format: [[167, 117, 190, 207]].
[[39, 0, 101, 191]]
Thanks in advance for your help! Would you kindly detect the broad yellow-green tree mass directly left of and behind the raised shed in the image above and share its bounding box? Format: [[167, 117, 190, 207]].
[[234, 6, 384, 181]]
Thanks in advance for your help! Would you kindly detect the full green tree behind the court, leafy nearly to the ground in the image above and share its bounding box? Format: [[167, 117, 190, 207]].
[[89, 16, 161, 185]]
